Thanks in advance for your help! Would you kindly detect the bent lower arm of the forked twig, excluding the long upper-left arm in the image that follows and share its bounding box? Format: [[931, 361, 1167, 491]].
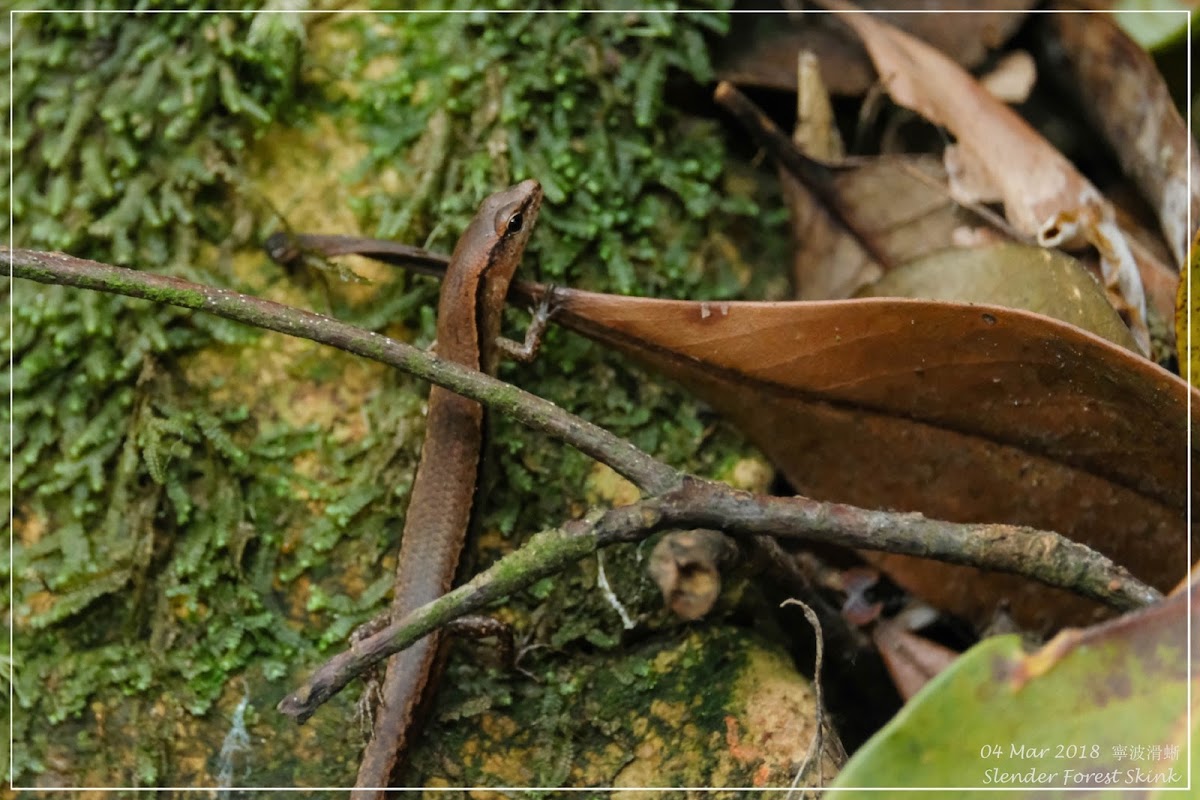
[[278, 476, 1162, 722]]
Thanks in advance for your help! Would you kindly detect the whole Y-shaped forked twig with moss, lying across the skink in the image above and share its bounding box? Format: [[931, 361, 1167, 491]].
[[0, 248, 1160, 720]]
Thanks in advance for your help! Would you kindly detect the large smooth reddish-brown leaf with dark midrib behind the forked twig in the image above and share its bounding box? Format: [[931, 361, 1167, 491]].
[[549, 290, 1189, 628]]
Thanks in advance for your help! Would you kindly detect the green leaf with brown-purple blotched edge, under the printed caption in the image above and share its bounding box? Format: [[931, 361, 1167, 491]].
[[833, 568, 1200, 798]]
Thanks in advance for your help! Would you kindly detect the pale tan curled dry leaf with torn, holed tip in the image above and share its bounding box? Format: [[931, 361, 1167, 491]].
[[822, 0, 1150, 354]]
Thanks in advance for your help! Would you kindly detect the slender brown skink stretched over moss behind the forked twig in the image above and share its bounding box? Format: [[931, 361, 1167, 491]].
[[353, 180, 541, 800]]
